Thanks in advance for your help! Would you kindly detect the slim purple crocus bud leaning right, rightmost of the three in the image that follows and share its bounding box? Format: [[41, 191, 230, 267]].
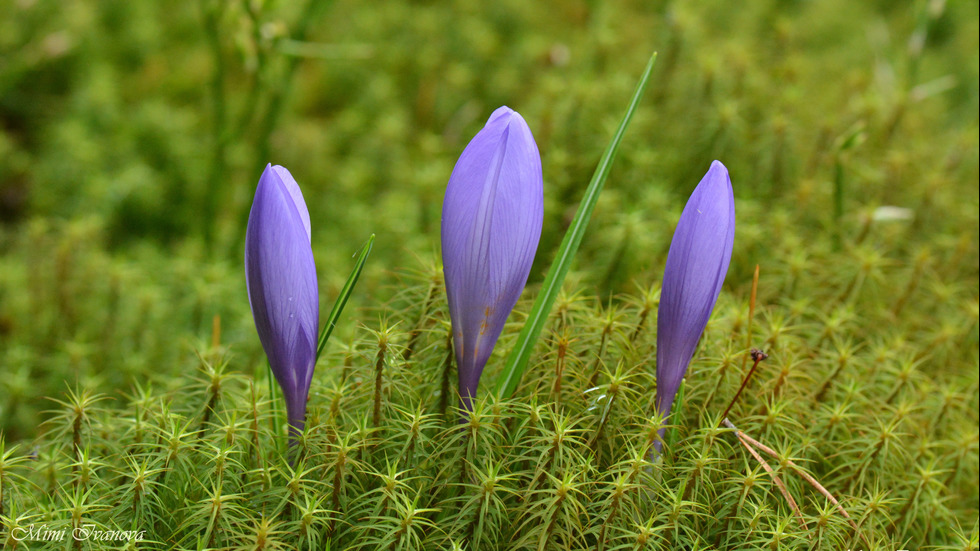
[[656, 161, 735, 452]]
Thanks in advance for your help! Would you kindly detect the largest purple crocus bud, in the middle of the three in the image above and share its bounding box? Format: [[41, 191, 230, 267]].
[[442, 107, 544, 411]]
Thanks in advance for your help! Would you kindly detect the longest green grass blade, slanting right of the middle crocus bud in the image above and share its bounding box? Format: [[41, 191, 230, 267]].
[[497, 53, 657, 398]]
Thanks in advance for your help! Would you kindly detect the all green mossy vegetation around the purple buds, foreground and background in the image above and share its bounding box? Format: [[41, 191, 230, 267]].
[[0, 0, 980, 551]]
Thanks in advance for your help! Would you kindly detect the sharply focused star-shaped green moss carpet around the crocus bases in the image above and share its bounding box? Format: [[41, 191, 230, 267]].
[[0, 253, 977, 549]]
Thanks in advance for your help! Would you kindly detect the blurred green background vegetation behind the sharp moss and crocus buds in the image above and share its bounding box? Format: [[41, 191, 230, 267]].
[[0, 0, 978, 439]]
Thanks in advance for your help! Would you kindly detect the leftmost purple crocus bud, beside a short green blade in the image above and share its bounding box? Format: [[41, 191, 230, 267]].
[[245, 165, 320, 436]]
